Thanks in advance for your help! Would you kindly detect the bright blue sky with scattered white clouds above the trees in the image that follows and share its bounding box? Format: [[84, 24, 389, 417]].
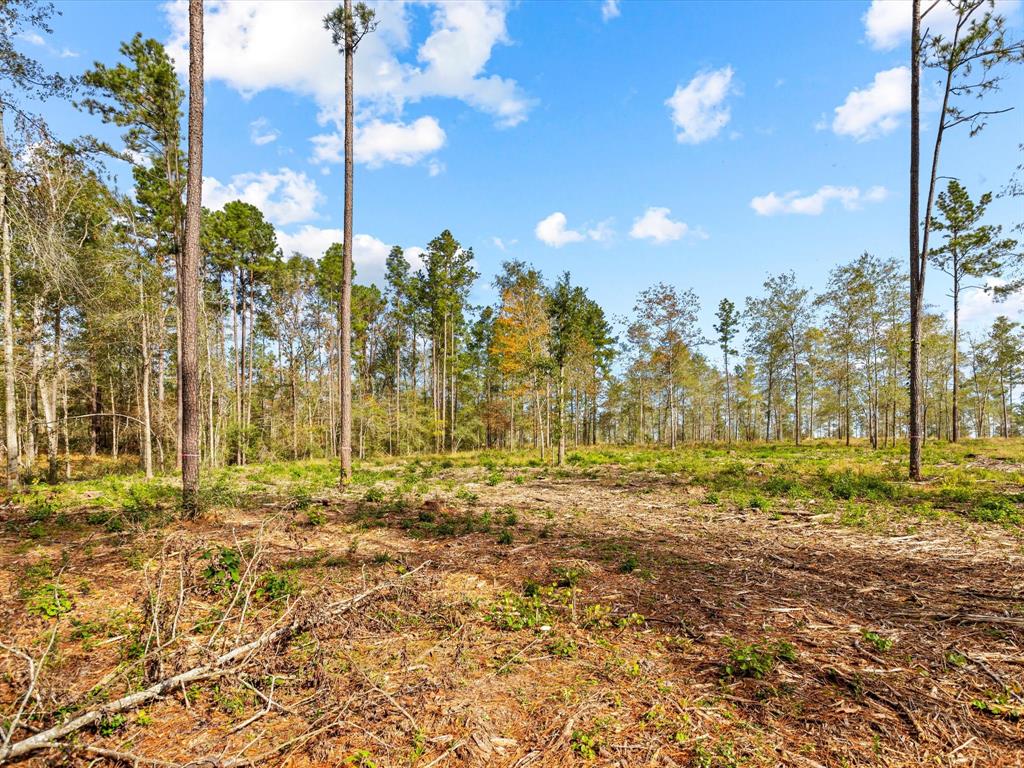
[[25, 0, 1024, 339]]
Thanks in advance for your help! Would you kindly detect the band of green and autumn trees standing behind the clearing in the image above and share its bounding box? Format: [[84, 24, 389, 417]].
[[0, 1, 1024, 493]]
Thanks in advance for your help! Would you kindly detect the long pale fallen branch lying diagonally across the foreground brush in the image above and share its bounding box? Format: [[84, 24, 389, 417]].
[[0, 560, 430, 764]]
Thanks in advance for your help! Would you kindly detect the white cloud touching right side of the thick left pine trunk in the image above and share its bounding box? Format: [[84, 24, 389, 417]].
[[203, 168, 323, 225]]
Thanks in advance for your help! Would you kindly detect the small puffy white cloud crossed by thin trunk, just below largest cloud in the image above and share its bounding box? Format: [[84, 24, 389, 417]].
[[310, 117, 445, 167]]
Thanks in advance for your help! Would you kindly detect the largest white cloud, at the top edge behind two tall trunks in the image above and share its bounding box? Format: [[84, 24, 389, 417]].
[[164, 0, 532, 133]]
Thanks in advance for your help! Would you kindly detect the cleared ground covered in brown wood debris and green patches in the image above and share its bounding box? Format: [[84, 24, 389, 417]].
[[0, 440, 1024, 768]]
